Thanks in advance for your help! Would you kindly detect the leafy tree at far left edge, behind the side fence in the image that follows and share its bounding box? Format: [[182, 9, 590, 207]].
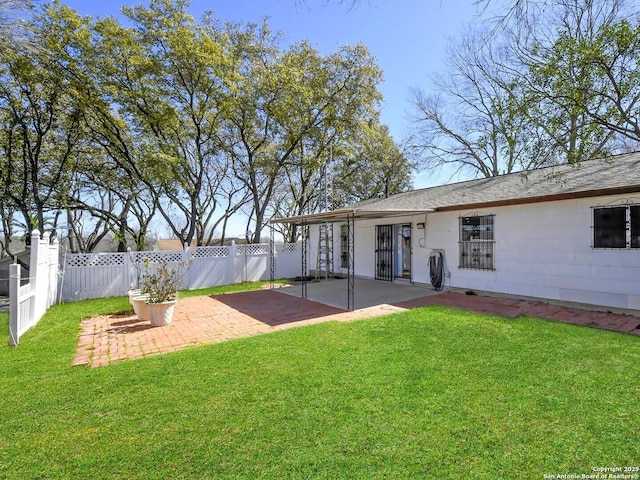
[[0, 1, 83, 244]]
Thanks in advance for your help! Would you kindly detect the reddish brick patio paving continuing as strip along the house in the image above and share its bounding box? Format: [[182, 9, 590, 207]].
[[73, 290, 640, 367]]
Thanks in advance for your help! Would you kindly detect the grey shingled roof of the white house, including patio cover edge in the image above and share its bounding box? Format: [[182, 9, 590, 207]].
[[276, 152, 640, 223]]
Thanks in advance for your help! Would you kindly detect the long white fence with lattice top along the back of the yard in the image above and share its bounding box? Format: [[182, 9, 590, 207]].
[[62, 243, 301, 302]]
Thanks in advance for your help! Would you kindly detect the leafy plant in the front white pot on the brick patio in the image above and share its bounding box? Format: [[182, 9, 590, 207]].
[[138, 260, 189, 327]]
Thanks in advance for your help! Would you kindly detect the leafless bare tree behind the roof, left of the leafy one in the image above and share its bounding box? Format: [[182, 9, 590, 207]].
[[411, 31, 541, 177]]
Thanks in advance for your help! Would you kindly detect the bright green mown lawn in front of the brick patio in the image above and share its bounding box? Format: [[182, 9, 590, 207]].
[[0, 286, 640, 479]]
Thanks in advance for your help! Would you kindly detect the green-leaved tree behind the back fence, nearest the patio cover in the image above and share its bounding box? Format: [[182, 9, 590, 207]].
[[225, 23, 388, 242]]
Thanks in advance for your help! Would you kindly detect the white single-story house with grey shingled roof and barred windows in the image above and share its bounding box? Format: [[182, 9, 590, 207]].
[[273, 153, 640, 310]]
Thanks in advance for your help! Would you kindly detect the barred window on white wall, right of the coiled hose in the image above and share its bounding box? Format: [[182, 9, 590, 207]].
[[458, 215, 495, 270]]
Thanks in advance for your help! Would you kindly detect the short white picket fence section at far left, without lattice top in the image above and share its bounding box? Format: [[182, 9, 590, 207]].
[[9, 230, 60, 346]]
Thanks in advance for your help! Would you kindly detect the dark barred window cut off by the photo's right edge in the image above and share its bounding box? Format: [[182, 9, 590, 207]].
[[593, 205, 640, 249]]
